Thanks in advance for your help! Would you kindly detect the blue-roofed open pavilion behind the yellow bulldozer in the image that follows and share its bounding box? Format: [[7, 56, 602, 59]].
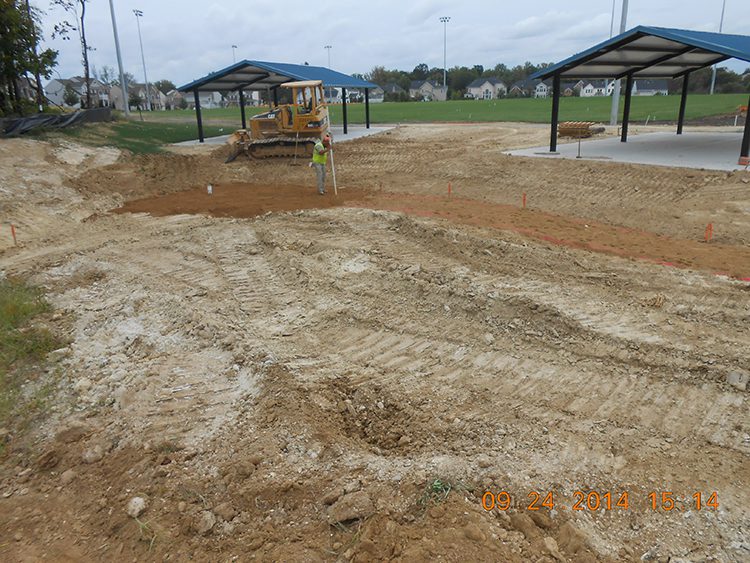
[[178, 60, 376, 143]]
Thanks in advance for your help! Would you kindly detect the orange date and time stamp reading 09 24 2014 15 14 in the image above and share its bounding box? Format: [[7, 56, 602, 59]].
[[482, 491, 719, 512]]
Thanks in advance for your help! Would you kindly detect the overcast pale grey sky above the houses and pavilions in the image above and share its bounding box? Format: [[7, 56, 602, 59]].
[[31, 0, 750, 86]]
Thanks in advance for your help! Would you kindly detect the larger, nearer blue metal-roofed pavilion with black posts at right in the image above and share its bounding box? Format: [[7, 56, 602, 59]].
[[531, 26, 750, 165]]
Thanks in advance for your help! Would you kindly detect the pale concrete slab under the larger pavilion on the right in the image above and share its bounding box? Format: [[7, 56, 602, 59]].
[[507, 130, 747, 170]]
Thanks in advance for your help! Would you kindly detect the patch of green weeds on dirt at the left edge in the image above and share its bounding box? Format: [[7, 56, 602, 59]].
[[0, 279, 60, 430]]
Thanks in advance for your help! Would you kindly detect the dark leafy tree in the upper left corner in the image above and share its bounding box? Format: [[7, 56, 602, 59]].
[[0, 0, 57, 115]]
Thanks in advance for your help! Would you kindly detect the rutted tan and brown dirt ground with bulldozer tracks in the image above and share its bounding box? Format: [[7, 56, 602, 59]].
[[0, 125, 750, 563]]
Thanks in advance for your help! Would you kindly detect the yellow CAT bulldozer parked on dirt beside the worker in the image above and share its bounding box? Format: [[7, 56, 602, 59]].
[[226, 80, 329, 162]]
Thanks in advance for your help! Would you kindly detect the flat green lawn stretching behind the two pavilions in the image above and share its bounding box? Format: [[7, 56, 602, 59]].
[[147, 94, 748, 129]]
